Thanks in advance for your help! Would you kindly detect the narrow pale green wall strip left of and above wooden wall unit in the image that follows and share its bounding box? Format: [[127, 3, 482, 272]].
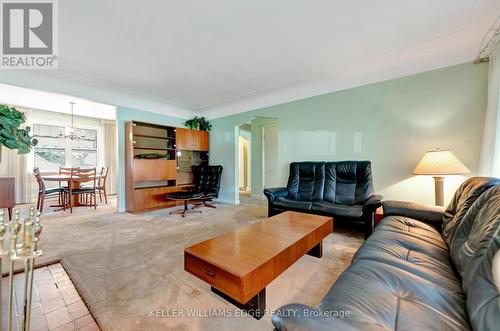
[[116, 106, 185, 211]]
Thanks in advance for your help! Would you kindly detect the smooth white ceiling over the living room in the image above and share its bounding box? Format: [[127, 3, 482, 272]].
[[1, 0, 500, 118]]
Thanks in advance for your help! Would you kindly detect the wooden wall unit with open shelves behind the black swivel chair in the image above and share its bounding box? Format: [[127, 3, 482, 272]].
[[125, 122, 208, 213]]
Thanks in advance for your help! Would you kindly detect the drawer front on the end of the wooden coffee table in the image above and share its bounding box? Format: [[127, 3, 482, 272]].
[[184, 252, 245, 303]]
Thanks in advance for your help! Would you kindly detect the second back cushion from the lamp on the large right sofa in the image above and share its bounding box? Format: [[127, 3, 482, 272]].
[[450, 185, 500, 277]]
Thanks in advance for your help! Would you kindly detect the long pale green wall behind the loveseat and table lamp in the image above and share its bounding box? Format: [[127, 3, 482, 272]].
[[210, 63, 488, 203]]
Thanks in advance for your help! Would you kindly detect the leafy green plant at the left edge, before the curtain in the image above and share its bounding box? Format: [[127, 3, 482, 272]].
[[0, 105, 38, 154]]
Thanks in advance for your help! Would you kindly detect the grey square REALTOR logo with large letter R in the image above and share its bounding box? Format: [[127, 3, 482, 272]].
[[1, 0, 57, 69]]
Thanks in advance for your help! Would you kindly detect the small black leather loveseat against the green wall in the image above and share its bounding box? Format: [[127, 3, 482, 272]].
[[264, 161, 382, 237]]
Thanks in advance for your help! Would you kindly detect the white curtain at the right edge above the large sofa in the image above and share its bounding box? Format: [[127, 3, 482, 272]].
[[479, 39, 500, 177]]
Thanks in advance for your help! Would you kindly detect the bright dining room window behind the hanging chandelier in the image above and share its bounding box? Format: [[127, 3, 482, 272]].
[[33, 124, 97, 172]]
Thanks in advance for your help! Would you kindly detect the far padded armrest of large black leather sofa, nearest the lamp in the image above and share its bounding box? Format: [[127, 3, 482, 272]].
[[383, 201, 445, 225]]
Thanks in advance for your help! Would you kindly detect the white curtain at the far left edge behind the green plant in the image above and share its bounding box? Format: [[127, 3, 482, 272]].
[[0, 106, 36, 203]]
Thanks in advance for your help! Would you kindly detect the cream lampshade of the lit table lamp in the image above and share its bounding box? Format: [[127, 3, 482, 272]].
[[413, 150, 470, 176]]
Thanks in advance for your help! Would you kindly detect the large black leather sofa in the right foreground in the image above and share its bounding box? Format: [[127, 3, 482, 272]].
[[272, 177, 500, 331]]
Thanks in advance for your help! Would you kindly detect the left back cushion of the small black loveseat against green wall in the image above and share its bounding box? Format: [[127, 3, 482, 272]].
[[287, 162, 325, 201]]
